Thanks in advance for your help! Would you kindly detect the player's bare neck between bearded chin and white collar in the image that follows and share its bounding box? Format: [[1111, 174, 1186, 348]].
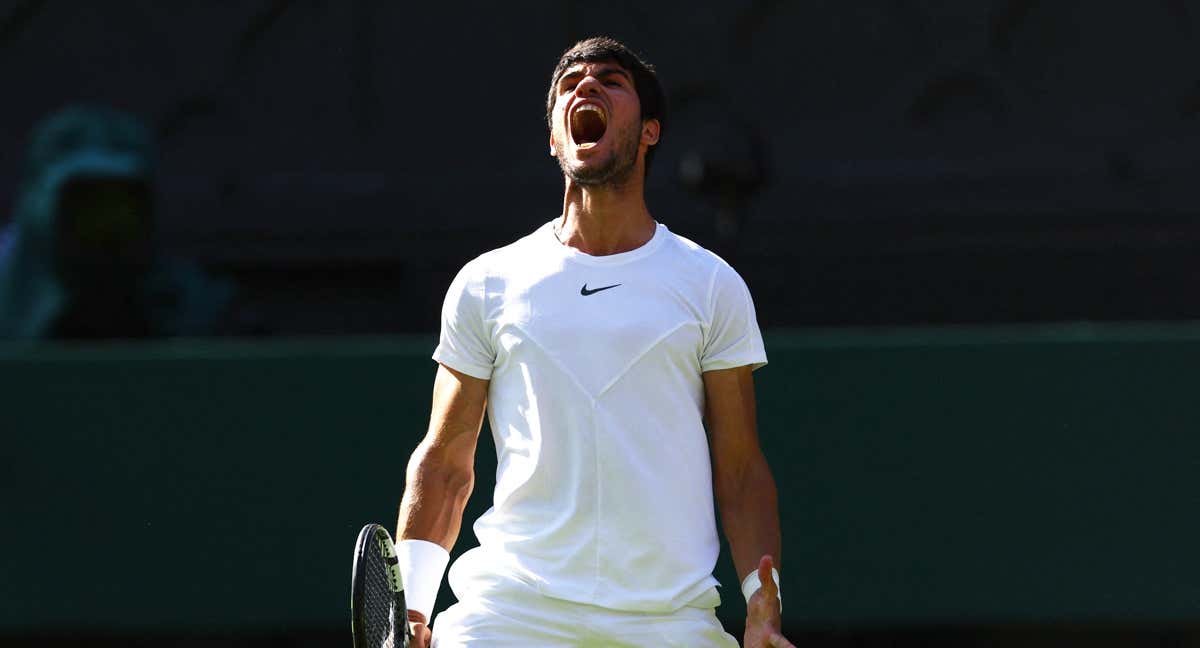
[[554, 171, 656, 257]]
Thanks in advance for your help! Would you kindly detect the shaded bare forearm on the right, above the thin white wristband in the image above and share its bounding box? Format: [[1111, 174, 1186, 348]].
[[716, 454, 780, 578]]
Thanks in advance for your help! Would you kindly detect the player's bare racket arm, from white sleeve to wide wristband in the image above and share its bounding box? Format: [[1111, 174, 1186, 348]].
[[396, 365, 488, 551]]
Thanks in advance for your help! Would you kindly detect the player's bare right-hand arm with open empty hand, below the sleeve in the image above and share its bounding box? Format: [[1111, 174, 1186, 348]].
[[703, 365, 792, 648]]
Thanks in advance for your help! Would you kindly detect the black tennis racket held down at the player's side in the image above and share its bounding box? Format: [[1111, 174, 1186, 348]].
[[350, 524, 413, 648]]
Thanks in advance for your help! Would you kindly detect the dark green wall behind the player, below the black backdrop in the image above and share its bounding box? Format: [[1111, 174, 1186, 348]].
[[0, 325, 1200, 631]]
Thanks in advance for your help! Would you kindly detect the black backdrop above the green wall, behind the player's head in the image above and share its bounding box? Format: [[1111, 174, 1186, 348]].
[[0, 0, 1200, 334]]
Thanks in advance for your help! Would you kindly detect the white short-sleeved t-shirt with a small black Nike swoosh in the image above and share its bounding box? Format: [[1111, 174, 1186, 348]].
[[433, 217, 767, 612]]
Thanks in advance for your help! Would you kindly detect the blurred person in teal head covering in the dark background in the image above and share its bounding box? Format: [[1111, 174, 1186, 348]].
[[0, 106, 236, 340]]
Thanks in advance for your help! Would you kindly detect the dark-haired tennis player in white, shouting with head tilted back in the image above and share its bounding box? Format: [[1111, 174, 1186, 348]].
[[397, 38, 792, 648]]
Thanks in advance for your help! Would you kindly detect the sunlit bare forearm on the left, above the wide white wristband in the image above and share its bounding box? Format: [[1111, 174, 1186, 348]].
[[397, 442, 475, 551]]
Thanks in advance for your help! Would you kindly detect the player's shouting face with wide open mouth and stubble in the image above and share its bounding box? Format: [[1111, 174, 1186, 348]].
[[550, 61, 659, 186]]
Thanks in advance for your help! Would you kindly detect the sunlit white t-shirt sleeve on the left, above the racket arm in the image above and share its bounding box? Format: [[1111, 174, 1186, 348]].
[[433, 263, 496, 380]]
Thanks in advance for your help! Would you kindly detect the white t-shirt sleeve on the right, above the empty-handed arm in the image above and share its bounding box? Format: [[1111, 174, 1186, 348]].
[[700, 263, 767, 371]]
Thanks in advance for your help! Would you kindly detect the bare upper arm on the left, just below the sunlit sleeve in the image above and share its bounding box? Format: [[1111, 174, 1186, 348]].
[[422, 364, 488, 466]]
